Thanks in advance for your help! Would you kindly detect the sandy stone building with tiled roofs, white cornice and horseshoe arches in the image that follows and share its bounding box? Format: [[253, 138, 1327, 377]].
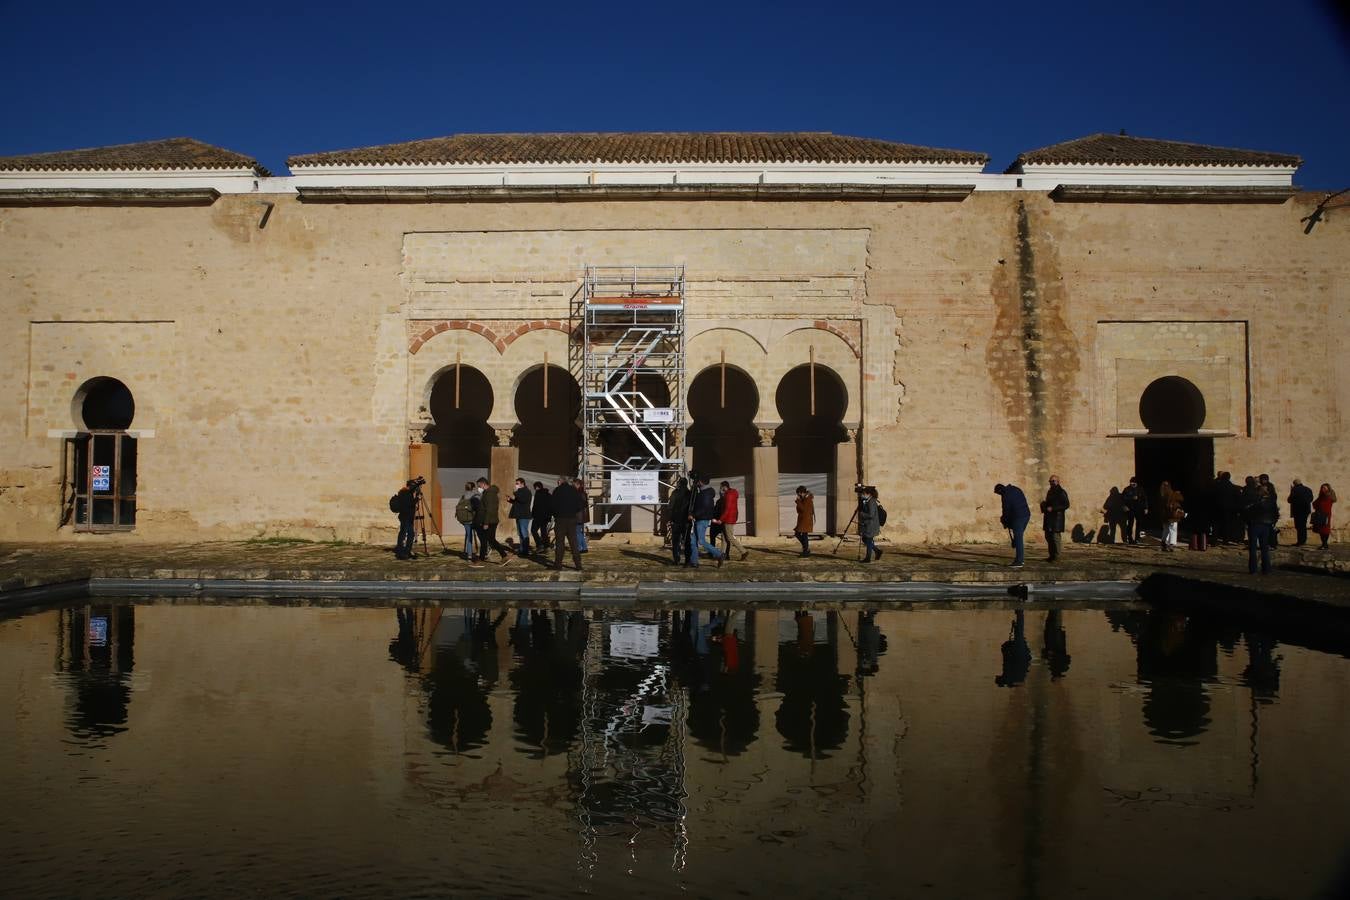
[[0, 135, 1350, 541]]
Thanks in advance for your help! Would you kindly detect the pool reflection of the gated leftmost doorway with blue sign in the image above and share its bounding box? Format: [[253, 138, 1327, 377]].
[[57, 604, 136, 738]]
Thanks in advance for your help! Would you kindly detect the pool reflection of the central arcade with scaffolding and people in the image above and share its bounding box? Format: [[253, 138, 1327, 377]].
[[390, 607, 887, 868]]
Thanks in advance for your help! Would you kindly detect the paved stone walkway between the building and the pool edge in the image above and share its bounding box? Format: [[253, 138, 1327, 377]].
[[0, 537, 1350, 609]]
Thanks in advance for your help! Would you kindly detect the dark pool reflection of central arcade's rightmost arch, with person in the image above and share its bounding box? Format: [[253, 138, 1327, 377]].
[[774, 610, 849, 760]]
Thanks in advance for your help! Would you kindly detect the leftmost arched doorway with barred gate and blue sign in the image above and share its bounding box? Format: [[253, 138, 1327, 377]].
[[61, 376, 136, 532]]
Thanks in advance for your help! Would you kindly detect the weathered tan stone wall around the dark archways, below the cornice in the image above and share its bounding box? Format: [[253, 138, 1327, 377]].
[[0, 192, 1350, 540]]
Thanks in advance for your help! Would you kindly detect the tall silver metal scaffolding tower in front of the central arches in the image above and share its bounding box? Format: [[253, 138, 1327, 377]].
[[568, 266, 686, 530]]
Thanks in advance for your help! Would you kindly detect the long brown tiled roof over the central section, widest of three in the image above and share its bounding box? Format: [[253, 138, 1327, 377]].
[[286, 131, 990, 167]]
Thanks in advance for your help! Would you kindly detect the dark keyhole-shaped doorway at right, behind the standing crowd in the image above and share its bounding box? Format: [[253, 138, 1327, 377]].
[[1134, 375, 1215, 530]]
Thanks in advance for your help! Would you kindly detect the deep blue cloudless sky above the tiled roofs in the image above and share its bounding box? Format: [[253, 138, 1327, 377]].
[[0, 0, 1350, 190]]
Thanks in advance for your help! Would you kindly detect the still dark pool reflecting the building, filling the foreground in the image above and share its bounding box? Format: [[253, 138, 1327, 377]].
[[0, 602, 1350, 897]]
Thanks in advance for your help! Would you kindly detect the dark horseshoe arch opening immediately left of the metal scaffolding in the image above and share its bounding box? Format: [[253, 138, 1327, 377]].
[[502, 366, 582, 490]]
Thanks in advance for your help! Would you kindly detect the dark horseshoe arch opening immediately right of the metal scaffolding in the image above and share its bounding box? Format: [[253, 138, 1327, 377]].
[[684, 366, 759, 534]]
